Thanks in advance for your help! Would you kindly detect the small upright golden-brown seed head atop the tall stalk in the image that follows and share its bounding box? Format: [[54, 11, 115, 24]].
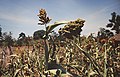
[[38, 9, 51, 25]]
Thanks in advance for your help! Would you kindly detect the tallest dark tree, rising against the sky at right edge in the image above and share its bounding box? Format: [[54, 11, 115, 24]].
[[106, 12, 120, 34]]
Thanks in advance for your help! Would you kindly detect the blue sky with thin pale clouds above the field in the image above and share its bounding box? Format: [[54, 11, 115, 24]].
[[0, 0, 120, 38]]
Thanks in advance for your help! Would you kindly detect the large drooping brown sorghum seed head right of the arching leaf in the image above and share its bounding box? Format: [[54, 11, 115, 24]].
[[58, 19, 85, 39]]
